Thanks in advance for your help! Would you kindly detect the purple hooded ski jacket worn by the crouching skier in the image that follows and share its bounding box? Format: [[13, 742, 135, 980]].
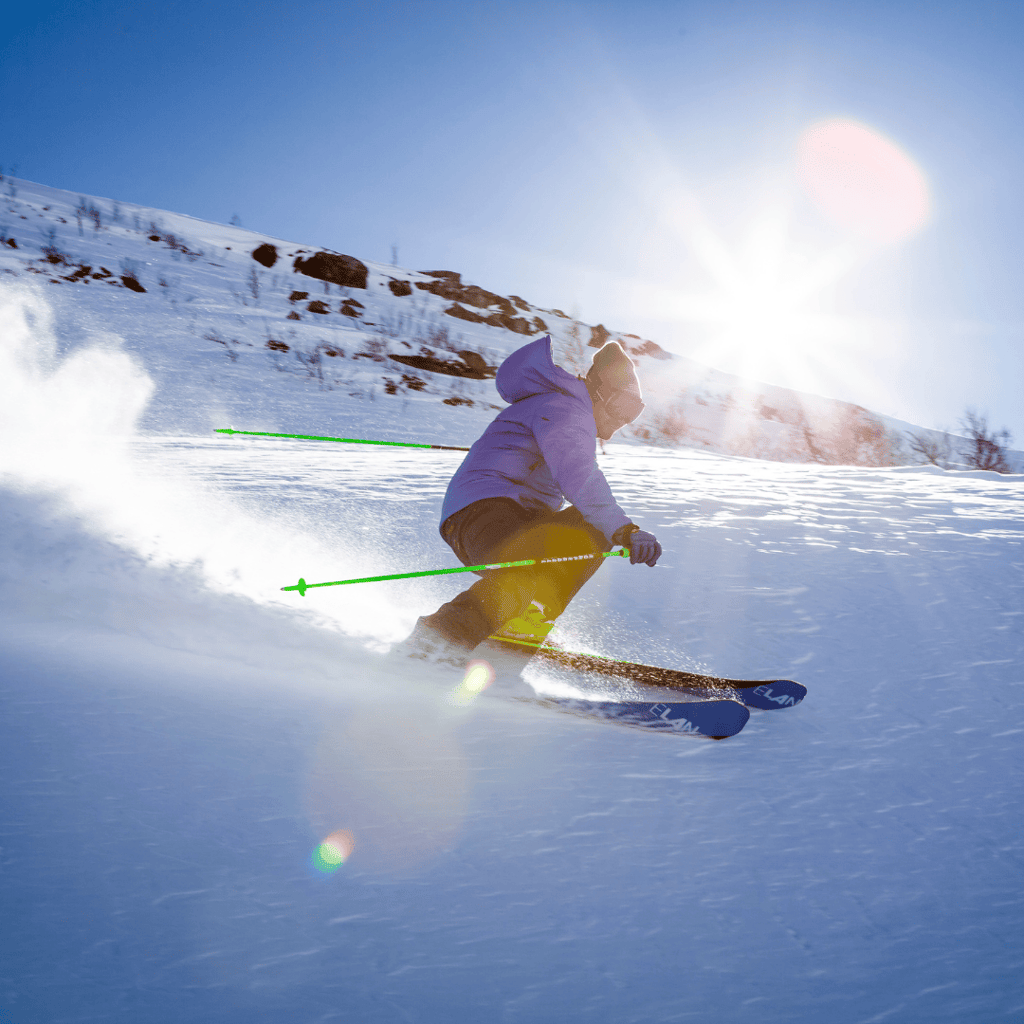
[[441, 335, 630, 543]]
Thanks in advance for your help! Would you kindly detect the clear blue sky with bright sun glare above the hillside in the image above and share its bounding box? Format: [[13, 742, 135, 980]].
[[0, 0, 1024, 445]]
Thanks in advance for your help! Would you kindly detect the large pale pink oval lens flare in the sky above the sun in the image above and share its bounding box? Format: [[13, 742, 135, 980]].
[[797, 118, 932, 243]]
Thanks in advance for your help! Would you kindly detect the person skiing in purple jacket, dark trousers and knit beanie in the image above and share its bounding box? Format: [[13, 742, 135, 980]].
[[400, 335, 662, 667]]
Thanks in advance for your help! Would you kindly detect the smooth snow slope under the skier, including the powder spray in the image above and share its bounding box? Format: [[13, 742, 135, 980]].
[[0, 186, 1024, 1024]]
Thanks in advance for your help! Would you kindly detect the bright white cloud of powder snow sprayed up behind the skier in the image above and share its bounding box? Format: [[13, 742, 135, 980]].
[[0, 282, 401, 639]]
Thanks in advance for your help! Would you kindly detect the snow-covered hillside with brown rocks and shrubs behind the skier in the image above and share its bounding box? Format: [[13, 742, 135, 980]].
[[0, 178, 1003, 465]]
